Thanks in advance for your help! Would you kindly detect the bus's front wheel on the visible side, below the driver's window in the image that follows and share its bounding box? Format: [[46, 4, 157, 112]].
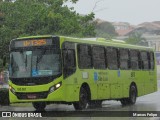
[[73, 87, 88, 110]]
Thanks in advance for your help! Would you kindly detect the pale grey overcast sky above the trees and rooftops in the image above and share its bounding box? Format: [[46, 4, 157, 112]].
[[67, 0, 160, 25]]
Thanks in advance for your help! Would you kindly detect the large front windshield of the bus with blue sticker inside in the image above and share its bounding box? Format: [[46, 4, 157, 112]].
[[10, 49, 61, 78]]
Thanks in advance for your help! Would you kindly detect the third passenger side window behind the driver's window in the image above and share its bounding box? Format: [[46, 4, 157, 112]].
[[106, 47, 119, 70]]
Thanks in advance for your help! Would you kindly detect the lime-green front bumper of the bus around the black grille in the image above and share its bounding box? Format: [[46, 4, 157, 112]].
[[9, 82, 64, 103]]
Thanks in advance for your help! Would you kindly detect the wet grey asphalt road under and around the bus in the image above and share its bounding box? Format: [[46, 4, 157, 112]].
[[0, 80, 160, 120]]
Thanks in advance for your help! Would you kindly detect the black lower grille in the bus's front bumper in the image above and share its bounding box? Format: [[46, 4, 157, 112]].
[[16, 91, 48, 100]]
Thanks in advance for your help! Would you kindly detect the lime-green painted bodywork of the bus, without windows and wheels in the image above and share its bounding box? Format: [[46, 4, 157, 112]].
[[9, 37, 157, 103]]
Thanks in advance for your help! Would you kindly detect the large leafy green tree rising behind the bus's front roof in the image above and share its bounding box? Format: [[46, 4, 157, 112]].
[[0, 0, 95, 37]]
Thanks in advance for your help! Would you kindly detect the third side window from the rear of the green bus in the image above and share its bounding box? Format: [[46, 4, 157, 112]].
[[129, 50, 140, 70]]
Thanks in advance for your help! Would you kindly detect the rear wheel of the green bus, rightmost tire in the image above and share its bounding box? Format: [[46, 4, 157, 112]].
[[128, 85, 137, 105]]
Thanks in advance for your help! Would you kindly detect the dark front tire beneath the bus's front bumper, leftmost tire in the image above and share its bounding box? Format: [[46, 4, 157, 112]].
[[32, 102, 46, 111]]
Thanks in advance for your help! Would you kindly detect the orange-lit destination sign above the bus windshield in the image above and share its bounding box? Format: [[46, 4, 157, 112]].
[[15, 39, 52, 47]]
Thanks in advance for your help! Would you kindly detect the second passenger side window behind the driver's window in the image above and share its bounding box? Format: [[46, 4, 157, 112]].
[[92, 46, 106, 69]]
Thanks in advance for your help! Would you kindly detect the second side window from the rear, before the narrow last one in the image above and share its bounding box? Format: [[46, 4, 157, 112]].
[[140, 51, 149, 70]]
